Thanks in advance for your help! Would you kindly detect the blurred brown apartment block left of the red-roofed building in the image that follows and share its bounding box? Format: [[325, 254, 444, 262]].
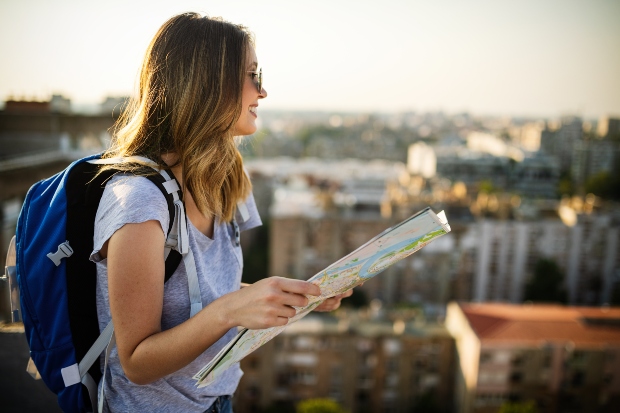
[[235, 316, 454, 413]]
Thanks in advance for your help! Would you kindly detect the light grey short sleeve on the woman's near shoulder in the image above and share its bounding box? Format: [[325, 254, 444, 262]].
[[90, 175, 170, 262]]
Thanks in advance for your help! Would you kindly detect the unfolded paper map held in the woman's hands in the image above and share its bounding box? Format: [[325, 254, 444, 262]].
[[193, 208, 450, 387]]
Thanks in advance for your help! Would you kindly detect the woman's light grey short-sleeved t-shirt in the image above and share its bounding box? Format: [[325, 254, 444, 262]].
[[91, 175, 261, 413]]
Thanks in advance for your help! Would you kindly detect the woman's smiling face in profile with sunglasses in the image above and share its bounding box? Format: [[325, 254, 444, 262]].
[[235, 46, 267, 136]]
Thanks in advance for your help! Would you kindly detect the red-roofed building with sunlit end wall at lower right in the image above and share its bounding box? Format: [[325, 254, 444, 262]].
[[446, 302, 620, 413]]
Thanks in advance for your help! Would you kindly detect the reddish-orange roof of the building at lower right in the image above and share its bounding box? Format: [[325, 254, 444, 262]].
[[459, 303, 620, 346]]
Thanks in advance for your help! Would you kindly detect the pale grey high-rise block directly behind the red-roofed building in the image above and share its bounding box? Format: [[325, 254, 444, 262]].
[[463, 214, 620, 305]]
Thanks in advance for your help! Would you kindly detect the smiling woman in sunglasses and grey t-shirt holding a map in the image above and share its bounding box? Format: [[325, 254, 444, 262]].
[[91, 13, 350, 412]]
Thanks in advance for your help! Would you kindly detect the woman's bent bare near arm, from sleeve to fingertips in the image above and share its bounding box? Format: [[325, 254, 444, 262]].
[[106, 221, 320, 384]]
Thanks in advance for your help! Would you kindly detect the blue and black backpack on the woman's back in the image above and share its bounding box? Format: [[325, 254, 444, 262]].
[[10, 155, 191, 412]]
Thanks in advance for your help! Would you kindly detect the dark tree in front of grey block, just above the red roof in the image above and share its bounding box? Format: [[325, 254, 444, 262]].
[[523, 258, 567, 304]]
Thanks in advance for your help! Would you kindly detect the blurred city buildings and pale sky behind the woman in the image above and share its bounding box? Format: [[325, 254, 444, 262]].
[[0, 0, 620, 413]]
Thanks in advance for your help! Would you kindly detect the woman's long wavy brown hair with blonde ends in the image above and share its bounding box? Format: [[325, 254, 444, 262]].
[[103, 13, 254, 221]]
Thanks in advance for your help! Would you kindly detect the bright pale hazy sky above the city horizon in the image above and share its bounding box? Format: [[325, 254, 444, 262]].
[[0, 0, 620, 117]]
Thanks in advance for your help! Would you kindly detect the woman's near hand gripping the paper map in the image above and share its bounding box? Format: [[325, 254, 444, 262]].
[[216, 277, 321, 330]]
